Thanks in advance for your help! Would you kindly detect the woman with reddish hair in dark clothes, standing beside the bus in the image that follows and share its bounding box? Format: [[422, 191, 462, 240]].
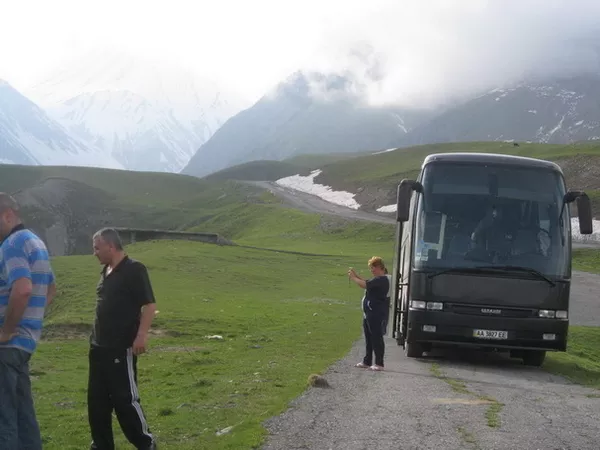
[[348, 256, 391, 371]]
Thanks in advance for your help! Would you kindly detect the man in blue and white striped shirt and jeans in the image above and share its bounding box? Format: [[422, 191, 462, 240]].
[[0, 192, 56, 450]]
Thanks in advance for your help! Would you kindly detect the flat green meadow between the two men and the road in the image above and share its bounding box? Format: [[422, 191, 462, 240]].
[[32, 241, 376, 449]]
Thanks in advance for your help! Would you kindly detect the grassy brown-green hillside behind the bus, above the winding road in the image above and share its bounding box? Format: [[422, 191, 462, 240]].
[[185, 142, 600, 217]]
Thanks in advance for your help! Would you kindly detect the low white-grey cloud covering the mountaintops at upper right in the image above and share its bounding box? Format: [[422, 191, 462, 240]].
[[305, 0, 600, 107]]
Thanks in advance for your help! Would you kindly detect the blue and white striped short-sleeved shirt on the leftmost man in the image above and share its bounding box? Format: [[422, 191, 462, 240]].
[[0, 227, 54, 353]]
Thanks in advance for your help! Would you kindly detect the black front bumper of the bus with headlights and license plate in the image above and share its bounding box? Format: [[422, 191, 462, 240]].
[[408, 310, 569, 351]]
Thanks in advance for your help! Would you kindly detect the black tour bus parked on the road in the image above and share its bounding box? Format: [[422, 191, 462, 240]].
[[391, 153, 592, 366]]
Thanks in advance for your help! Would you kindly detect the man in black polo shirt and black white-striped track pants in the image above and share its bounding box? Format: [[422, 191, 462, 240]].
[[88, 228, 157, 450]]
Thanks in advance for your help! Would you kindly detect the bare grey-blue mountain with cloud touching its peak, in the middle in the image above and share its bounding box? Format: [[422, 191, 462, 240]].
[[183, 72, 424, 176]]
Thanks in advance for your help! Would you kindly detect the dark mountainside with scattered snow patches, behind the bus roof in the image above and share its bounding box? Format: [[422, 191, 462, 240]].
[[404, 76, 600, 145]]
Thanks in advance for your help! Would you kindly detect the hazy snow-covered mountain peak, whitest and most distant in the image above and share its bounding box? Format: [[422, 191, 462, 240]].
[[27, 51, 243, 172]]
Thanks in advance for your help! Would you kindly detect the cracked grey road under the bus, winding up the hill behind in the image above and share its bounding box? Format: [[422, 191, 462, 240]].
[[254, 182, 600, 450]]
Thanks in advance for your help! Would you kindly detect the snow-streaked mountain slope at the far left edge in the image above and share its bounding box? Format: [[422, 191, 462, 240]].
[[0, 80, 123, 169]]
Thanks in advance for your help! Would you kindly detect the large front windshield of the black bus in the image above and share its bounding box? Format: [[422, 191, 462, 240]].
[[413, 163, 570, 278]]
